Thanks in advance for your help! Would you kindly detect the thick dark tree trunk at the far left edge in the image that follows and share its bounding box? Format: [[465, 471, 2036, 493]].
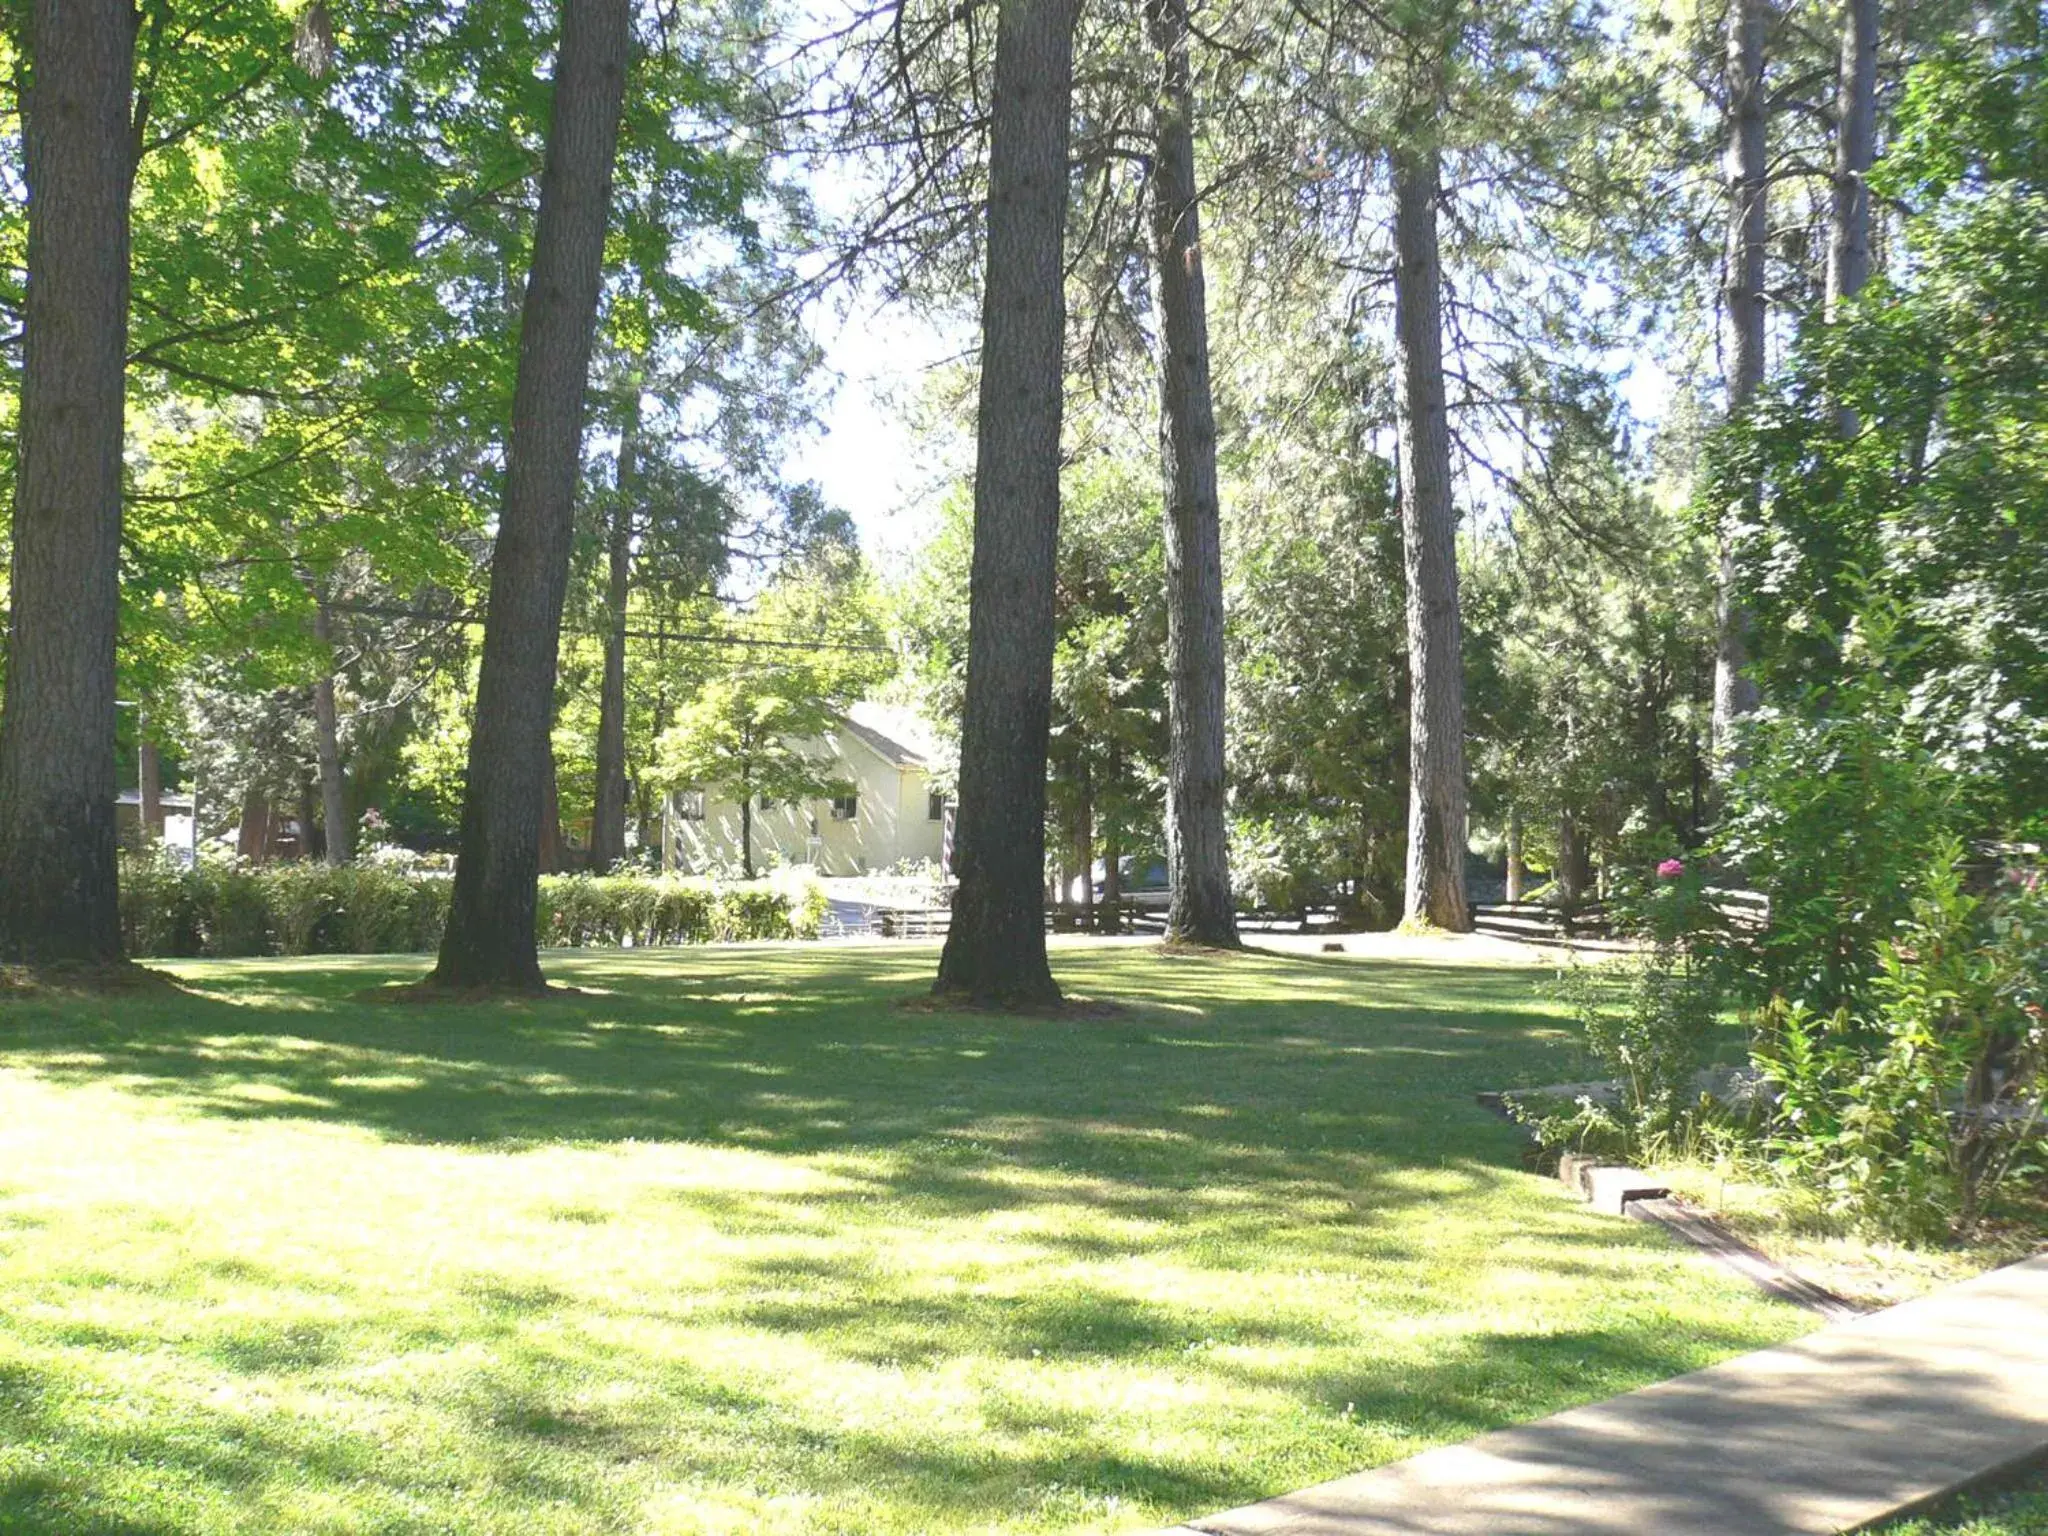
[[0, 0, 135, 965]]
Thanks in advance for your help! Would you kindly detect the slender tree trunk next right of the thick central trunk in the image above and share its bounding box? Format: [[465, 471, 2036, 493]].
[[1147, 0, 1237, 948]]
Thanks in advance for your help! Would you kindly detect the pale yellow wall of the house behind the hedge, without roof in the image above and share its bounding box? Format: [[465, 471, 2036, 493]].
[[670, 731, 944, 874]]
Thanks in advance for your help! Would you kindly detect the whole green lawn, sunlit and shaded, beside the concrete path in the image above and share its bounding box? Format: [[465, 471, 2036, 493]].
[[0, 940, 1810, 1536]]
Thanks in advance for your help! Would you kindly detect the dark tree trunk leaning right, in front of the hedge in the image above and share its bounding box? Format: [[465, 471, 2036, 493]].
[[434, 0, 633, 991]]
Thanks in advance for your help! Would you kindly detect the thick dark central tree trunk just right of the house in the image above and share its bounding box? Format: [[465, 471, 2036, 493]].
[[938, 0, 1077, 1006]]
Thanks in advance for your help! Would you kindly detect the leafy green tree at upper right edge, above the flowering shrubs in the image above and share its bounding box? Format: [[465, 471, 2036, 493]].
[[1718, 4, 2048, 834]]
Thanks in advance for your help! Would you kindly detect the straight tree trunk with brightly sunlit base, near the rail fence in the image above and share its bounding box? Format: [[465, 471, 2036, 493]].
[[1395, 147, 1473, 934]]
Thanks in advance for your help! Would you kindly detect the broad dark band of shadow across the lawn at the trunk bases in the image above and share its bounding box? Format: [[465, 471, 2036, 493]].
[[0, 950, 1554, 1165]]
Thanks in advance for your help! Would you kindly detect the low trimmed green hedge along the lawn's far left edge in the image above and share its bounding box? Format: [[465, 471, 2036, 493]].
[[121, 856, 825, 956]]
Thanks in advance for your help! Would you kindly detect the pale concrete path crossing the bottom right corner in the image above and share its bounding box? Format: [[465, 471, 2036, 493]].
[[1180, 1257, 2048, 1536]]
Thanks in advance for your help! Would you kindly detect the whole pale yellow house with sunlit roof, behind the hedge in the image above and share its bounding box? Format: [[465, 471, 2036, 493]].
[[662, 702, 952, 874]]
